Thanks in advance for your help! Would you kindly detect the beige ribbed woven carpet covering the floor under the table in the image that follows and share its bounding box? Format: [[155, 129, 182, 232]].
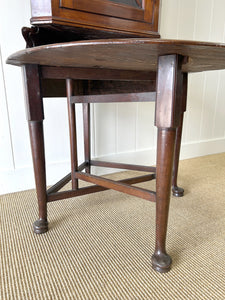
[[1, 153, 225, 300]]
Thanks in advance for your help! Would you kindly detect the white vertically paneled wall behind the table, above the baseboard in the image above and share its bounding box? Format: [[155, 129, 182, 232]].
[[0, 0, 225, 194]]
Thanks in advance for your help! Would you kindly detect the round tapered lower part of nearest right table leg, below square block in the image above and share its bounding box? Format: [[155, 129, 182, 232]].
[[152, 128, 176, 273]]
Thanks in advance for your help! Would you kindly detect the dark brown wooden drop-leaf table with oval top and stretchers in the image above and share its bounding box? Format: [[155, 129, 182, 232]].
[[7, 38, 225, 272]]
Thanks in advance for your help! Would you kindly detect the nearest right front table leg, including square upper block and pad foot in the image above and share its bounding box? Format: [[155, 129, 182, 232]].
[[152, 55, 186, 273]]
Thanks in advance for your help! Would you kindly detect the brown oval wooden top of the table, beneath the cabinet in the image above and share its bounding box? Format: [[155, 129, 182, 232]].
[[7, 38, 225, 72]]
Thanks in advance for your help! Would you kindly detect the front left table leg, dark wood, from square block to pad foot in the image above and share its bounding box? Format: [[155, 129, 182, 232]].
[[24, 65, 48, 234]]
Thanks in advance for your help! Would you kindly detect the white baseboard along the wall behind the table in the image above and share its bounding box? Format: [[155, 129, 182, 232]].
[[0, 138, 225, 195]]
